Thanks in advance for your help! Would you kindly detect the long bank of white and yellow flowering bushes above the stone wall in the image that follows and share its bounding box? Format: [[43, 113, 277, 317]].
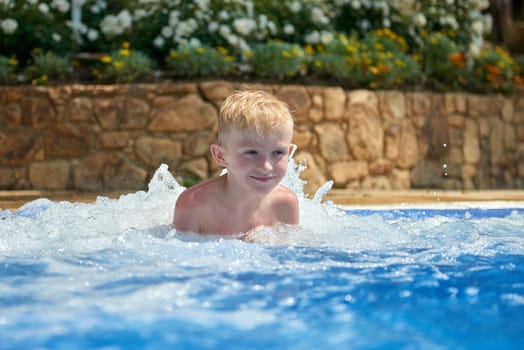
[[0, 0, 522, 91]]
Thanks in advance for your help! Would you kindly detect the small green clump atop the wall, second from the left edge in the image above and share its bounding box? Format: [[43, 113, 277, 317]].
[[24, 52, 71, 85]]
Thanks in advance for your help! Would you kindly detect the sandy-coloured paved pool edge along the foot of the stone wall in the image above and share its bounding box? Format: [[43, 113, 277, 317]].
[[0, 190, 524, 210]]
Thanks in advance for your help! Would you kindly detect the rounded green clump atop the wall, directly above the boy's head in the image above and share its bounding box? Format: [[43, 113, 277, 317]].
[[248, 41, 305, 80]]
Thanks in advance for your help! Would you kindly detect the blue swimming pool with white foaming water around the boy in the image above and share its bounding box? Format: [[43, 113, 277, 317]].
[[0, 167, 524, 349]]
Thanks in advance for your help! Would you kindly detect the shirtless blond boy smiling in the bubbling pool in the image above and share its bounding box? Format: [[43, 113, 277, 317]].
[[173, 91, 299, 235]]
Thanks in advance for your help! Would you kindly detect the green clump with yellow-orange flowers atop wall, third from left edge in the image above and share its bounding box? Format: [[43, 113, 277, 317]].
[[93, 42, 152, 83]]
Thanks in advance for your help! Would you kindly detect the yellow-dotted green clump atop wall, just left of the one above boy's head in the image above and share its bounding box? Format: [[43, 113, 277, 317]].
[[166, 45, 234, 77]]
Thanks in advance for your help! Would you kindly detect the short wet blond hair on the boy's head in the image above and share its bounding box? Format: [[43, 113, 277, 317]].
[[218, 90, 293, 143]]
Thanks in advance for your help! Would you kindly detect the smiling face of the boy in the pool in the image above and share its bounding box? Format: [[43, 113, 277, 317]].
[[215, 127, 293, 195]]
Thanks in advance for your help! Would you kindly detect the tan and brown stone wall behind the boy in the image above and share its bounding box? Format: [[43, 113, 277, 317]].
[[0, 81, 524, 191]]
